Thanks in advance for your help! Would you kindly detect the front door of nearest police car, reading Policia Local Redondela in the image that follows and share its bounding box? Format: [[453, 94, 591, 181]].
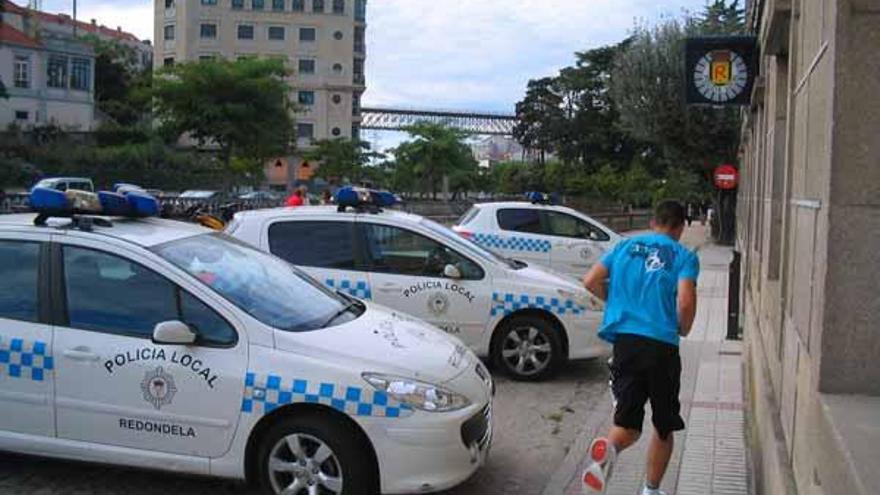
[[52, 240, 247, 457]]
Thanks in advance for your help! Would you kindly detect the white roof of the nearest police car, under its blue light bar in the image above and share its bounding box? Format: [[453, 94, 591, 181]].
[[0, 213, 214, 248]]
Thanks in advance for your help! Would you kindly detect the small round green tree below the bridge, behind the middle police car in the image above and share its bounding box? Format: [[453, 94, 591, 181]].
[[393, 122, 478, 197]]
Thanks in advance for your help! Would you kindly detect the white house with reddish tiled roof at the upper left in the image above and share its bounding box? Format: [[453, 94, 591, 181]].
[[0, 0, 152, 132]]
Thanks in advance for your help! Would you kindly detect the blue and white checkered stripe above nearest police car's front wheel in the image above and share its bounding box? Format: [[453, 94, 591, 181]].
[[241, 372, 413, 418]]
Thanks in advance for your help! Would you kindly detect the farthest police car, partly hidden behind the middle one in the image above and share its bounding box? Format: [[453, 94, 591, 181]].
[[453, 193, 621, 280]]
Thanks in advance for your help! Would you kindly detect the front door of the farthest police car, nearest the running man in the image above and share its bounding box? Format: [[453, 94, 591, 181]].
[[542, 211, 611, 278]]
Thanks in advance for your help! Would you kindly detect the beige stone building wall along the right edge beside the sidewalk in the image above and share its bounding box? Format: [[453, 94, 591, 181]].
[[737, 0, 880, 495]]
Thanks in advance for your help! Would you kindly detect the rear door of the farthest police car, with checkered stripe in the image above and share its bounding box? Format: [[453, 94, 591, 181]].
[[488, 208, 552, 267]]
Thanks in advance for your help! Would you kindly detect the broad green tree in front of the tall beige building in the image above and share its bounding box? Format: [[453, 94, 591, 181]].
[[153, 58, 294, 178]]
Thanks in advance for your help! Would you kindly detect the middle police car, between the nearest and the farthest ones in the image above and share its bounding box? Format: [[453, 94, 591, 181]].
[[227, 188, 607, 380]]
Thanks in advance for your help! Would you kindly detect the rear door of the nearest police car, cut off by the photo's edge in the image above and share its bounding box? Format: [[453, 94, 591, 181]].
[[0, 233, 55, 437]]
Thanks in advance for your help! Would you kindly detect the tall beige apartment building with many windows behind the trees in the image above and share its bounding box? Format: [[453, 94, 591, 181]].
[[154, 0, 366, 189]]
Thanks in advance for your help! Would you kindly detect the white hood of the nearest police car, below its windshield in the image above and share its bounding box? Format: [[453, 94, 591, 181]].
[[275, 303, 476, 384]]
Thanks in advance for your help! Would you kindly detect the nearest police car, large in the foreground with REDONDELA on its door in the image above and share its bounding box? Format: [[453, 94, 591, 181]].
[[0, 189, 492, 495]]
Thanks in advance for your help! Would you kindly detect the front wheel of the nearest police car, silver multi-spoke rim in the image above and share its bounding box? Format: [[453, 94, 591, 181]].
[[255, 413, 379, 495]]
